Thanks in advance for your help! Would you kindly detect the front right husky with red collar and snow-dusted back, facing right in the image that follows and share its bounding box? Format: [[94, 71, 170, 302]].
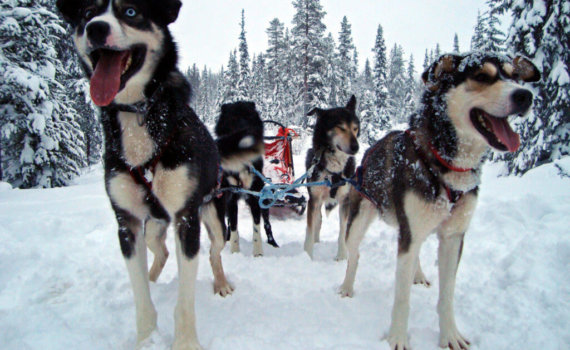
[[340, 52, 540, 350]]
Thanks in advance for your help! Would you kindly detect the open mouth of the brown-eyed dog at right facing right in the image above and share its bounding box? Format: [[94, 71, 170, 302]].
[[470, 108, 521, 152]]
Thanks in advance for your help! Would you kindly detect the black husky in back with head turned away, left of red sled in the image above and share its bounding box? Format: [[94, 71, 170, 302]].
[[215, 101, 277, 256]]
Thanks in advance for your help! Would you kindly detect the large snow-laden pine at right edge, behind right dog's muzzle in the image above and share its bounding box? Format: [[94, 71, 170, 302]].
[[488, 0, 570, 174]]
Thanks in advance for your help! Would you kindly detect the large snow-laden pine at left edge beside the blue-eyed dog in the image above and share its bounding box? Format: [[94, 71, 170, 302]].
[[0, 0, 87, 188]]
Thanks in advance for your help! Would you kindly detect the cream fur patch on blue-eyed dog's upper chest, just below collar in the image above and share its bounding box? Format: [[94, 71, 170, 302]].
[[118, 112, 156, 167]]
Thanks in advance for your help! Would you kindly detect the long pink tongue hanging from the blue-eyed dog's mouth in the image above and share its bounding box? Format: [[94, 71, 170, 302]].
[[91, 50, 129, 107]]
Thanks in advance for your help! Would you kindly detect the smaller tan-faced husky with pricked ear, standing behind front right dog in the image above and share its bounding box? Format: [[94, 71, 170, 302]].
[[305, 95, 360, 260]]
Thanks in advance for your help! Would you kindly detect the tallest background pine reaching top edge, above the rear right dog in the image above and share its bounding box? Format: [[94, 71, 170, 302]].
[[291, 0, 326, 127]]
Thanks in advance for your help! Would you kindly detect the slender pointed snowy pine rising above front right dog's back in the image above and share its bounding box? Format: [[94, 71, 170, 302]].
[[368, 24, 390, 134]]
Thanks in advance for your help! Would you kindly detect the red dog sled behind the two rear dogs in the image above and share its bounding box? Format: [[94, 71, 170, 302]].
[[263, 120, 307, 215]]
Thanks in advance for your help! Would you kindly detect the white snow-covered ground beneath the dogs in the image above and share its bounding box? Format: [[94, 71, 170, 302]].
[[0, 158, 570, 350]]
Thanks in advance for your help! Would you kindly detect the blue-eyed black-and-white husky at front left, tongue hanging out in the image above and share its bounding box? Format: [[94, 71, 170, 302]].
[[57, 0, 239, 349]]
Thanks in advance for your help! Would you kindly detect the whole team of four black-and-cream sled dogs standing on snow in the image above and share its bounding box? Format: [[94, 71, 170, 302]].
[[57, 0, 540, 350]]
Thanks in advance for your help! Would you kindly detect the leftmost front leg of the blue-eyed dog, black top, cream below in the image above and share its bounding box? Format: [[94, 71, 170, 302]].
[[114, 207, 156, 344]]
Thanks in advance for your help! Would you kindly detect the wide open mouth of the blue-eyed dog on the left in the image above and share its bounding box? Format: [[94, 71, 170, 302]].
[[89, 45, 146, 107]]
